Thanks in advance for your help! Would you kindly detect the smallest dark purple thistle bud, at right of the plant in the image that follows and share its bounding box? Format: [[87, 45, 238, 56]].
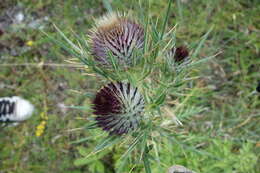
[[170, 46, 189, 62]]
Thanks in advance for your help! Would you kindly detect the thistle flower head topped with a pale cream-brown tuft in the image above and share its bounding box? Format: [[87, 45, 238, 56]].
[[90, 13, 144, 65]]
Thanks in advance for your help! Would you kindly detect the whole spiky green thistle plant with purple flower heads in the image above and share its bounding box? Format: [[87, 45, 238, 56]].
[[48, 0, 214, 172]]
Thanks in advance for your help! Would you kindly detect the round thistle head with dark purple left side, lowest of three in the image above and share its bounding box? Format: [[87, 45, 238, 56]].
[[93, 82, 145, 135]]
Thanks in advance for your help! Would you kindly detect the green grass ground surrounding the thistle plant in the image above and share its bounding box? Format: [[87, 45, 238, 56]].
[[0, 0, 260, 173]]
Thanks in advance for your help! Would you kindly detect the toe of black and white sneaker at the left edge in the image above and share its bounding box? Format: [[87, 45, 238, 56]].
[[0, 96, 34, 122]]
